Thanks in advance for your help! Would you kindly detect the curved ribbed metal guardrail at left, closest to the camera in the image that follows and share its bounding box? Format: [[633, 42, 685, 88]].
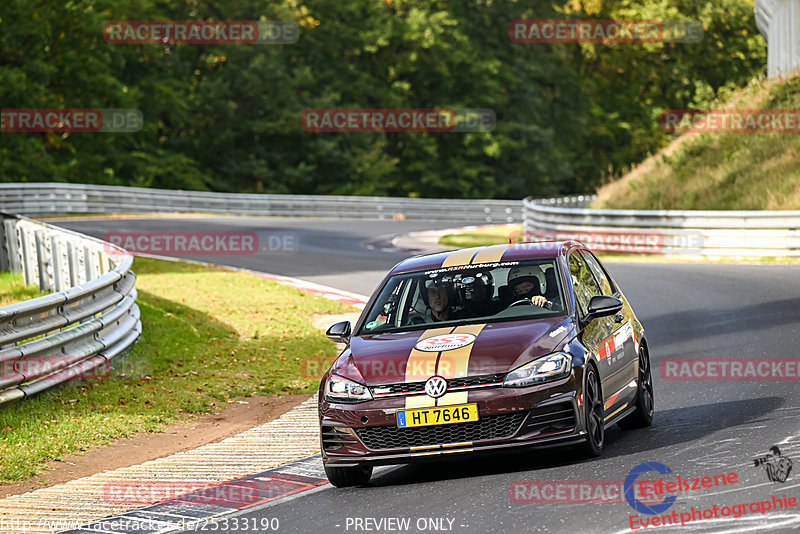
[[0, 213, 142, 404]]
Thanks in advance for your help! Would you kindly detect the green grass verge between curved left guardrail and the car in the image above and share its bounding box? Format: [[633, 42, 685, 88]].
[[0, 258, 354, 482]]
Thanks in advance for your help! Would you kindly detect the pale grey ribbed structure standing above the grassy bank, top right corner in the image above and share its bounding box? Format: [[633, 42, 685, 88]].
[[755, 0, 800, 78]]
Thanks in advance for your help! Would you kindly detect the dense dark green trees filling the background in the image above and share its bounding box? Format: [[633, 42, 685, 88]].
[[0, 0, 766, 198]]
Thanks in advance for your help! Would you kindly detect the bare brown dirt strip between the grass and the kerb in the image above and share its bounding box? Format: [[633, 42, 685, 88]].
[[0, 394, 309, 498]]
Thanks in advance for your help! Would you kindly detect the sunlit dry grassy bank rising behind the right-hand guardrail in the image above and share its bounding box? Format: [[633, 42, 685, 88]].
[[593, 77, 800, 210]]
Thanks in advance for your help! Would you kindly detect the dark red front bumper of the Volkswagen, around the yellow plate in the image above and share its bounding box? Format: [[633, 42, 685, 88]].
[[319, 367, 584, 467]]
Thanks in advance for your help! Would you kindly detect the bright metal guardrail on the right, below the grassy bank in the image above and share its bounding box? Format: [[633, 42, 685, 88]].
[[523, 197, 800, 257]]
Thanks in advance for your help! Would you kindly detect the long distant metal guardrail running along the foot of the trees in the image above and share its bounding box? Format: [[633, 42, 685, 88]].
[[0, 183, 522, 223]]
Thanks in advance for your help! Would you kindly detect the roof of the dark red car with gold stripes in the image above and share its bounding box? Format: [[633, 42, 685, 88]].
[[391, 241, 583, 274]]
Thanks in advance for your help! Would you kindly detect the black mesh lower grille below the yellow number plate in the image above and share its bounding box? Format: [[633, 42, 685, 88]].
[[355, 412, 525, 450]]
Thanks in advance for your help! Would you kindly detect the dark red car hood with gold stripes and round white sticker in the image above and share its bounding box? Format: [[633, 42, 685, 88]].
[[340, 317, 573, 386]]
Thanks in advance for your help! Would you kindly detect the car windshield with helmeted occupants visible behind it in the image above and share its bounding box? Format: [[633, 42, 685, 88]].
[[358, 258, 564, 335]]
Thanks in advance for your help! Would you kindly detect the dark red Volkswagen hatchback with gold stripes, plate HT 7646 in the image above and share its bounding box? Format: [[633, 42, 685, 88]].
[[319, 241, 653, 487]]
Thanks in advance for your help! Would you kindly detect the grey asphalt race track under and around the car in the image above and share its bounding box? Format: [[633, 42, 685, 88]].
[[58, 217, 800, 534]]
